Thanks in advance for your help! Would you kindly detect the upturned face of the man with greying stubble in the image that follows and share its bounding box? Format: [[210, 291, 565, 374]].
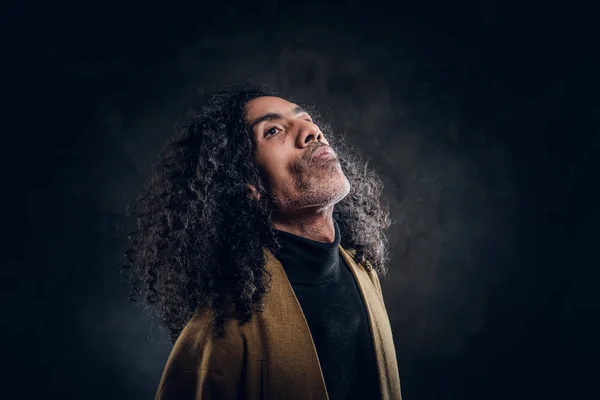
[[245, 96, 350, 216]]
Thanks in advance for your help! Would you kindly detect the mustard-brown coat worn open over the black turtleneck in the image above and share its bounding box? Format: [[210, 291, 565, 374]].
[[155, 246, 402, 400]]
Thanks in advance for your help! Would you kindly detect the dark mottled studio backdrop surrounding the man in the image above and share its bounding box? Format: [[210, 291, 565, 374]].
[[5, 0, 600, 399]]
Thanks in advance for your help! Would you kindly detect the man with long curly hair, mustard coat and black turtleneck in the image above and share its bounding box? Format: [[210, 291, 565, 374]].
[[127, 85, 401, 400]]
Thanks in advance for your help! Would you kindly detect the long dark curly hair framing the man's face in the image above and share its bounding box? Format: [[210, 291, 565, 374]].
[[121, 83, 390, 343]]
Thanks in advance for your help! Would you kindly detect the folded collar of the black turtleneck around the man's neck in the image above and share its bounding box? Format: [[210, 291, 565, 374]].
[[275, 220, 340, 285]]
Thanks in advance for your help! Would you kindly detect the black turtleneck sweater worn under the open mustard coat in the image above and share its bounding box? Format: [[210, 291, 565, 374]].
[[276, 221, 380, 400]]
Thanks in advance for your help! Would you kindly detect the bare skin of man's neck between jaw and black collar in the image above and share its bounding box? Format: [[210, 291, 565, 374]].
[[272, 206, 335, 243]]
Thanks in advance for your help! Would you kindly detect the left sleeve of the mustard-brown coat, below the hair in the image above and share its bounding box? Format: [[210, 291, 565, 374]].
[[154, 314, 243, 400]]
